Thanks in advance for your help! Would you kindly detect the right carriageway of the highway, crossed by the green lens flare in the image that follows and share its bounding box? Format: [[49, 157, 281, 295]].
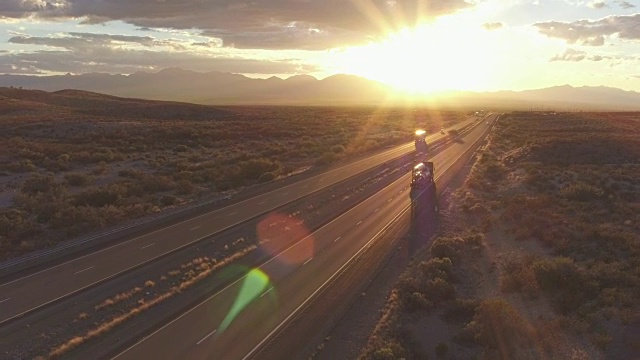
[[115, 115, 497, 360]]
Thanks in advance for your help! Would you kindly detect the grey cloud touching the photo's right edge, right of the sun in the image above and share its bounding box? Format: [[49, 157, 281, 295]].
[[534, 14, 640, 46]]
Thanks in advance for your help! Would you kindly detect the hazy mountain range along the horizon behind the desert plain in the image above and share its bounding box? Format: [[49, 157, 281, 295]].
[[0, 68, 640, 111]]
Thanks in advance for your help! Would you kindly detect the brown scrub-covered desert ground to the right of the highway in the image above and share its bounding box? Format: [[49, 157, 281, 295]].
[[316, 113, 640, 359]]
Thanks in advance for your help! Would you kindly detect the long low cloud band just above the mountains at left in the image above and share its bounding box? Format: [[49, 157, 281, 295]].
[[0, 32, 319, 74]]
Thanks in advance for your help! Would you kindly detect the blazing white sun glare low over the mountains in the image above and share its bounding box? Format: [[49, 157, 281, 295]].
[[340, 21, 497, 93]]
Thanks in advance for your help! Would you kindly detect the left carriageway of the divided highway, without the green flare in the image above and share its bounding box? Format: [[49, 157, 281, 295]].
[[0, 118, 478, 325]]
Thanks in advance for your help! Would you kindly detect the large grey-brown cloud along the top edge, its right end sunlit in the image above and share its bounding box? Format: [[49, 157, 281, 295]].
[[0, 0, 473, 49]]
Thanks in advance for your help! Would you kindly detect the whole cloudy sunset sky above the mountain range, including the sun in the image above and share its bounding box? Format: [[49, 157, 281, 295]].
[[0, 0, 640, 92]]
